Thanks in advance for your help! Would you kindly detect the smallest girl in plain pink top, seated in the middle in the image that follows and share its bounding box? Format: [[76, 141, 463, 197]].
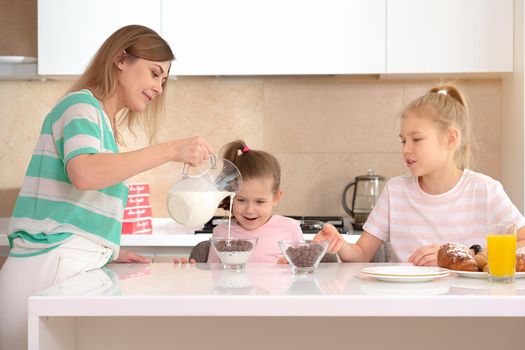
[[208, 140, 303, 263]]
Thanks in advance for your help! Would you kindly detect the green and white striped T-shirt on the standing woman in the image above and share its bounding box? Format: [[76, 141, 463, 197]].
[[9, 90, 128, 258]]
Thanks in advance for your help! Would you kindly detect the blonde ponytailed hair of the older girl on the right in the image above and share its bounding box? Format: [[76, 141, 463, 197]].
[[401, 83, 473, 170]]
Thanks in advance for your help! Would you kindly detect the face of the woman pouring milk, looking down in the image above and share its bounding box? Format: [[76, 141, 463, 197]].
[[117, 56, 171, 112]]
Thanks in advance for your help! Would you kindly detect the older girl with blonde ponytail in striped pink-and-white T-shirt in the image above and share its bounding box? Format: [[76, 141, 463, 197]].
[[314, 84, 525, 265]]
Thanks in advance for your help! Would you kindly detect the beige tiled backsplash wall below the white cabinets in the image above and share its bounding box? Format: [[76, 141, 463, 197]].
[[0, 76, 501, 217]]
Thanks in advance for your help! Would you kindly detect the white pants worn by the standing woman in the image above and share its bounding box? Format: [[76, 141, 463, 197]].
[[0, 235, 112, 350]]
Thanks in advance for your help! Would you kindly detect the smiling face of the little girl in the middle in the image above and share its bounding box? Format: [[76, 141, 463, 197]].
[[233, 178, 282, 231]]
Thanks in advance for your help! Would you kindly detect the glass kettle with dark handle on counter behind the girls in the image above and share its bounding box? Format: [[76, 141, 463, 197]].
[[342, 169, 385, 230]]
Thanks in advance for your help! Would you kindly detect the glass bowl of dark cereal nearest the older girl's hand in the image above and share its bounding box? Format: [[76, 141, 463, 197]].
[[279, 241, 328, 275]]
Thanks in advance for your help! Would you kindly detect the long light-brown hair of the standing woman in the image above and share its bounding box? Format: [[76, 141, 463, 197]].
[[69, 25, 175, 144]]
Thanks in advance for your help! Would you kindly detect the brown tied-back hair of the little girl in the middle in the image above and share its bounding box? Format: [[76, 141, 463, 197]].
[[220, 140, 281, 210]]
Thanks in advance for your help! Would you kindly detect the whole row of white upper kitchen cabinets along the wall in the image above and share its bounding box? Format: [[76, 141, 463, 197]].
[[38, 0, 513, 75]]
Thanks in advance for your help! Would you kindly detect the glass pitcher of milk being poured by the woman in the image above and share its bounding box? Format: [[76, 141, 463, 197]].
[[168, 155, 242, 226]]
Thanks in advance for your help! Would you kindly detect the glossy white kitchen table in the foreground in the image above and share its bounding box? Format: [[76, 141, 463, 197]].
[[29, 264, 525, 350]]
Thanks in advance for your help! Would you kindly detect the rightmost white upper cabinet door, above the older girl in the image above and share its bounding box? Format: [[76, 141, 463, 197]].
[[386, 0, 513, 73]]
